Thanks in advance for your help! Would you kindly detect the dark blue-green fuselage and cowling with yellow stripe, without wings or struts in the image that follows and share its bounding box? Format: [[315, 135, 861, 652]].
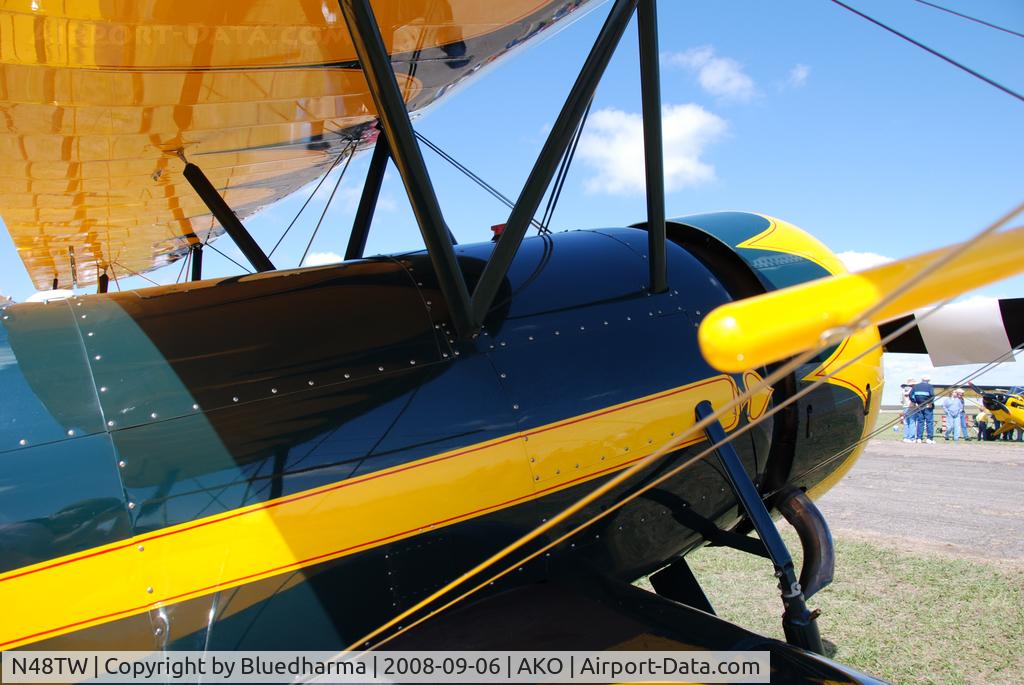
[[0, 213, 881, 671]]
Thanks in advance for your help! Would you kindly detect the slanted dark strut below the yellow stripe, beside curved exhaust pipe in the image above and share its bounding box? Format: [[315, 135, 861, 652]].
[[696, 400, 824, 654]]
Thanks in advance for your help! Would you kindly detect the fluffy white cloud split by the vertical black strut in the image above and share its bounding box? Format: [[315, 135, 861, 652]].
[[579, 104, 726, 195]]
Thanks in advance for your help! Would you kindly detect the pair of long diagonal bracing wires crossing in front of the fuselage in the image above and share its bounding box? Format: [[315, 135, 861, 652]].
[[319, 198, 1024, 653]]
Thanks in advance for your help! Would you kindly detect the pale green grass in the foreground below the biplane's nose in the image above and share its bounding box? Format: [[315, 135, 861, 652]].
[[663, 523, 1024, 685]]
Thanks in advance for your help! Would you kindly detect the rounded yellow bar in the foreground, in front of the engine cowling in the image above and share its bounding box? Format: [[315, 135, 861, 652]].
[[697, 227, 1024, 373]]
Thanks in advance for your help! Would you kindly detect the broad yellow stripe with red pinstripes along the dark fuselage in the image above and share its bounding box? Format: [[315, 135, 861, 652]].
[[0, 375, 739, 649]]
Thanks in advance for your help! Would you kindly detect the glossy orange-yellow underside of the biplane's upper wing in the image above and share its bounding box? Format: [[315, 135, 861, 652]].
[[0, 0, 586, 290]]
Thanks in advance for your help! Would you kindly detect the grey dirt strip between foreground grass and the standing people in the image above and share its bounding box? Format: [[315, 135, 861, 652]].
[[818, 439, 1024, 565]]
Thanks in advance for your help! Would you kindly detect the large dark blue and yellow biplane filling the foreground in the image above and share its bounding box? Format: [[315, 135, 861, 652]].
[[0, 0, 1021, 683]]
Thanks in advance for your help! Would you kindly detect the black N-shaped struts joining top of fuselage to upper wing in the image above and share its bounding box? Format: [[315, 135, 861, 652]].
[[338, 0, 667, 336]]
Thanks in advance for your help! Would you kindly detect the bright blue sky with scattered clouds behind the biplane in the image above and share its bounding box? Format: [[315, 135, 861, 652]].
[[0, 0, 1024, 401]]
